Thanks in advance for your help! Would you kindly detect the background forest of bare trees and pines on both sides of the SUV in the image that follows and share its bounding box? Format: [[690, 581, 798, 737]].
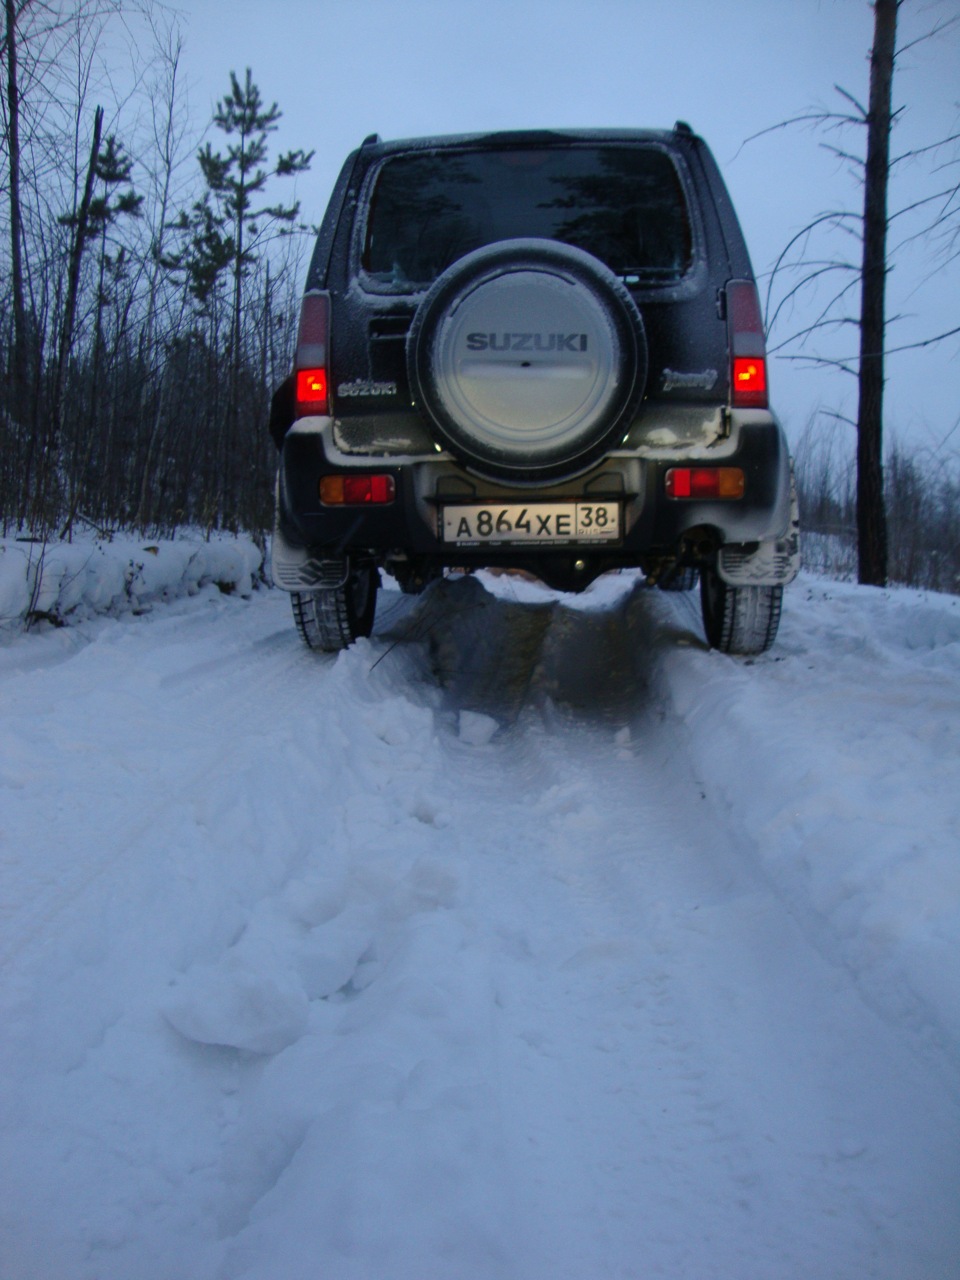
[[0, 0, 960, 593]]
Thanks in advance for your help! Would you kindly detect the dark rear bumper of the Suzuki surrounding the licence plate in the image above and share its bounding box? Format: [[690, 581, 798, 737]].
[[274, 411, 792, 590]]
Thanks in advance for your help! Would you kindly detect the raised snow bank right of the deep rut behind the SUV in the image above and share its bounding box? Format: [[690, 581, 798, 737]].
[[658, 575, 960, 1051]]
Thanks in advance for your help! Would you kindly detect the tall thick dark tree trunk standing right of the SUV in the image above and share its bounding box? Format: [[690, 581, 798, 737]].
[[856, 0, 900, 586]]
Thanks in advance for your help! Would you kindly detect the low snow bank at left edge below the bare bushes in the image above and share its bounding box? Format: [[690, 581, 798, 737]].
[[0, 534, 261, 625]]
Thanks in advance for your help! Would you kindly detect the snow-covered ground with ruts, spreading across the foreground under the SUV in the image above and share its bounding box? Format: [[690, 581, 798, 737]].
[[0, 548, 960, 1280]]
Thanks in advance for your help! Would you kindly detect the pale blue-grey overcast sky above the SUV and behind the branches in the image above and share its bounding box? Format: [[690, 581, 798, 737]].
[[179, 0, 960, 453]]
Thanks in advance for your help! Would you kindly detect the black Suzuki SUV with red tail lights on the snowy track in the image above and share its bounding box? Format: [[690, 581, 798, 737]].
[[271, 123, 799, 654]]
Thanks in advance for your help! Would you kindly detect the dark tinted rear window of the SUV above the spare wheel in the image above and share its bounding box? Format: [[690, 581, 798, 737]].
[[362, 145, 692, 292]]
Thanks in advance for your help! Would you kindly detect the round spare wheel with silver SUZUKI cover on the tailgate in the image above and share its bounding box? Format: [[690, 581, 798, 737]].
[[407, 239, 646, 480]]
